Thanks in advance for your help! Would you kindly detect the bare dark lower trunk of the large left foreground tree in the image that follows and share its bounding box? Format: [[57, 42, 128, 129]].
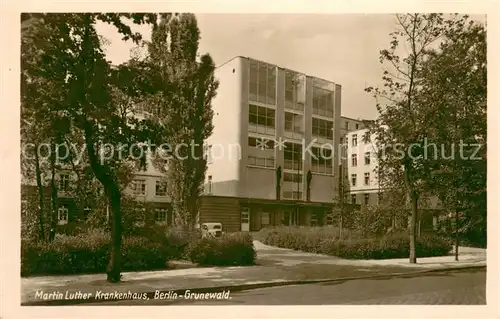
[[106, 185, 122, 282]]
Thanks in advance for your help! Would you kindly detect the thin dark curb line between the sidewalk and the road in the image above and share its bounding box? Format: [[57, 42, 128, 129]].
[[21, 265, 486, 306]]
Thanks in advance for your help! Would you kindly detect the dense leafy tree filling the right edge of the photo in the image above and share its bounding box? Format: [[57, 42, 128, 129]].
[[419, 16, 487, 252]]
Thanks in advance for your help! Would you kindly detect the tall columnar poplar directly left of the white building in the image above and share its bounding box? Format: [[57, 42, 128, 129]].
[[141, 14, 218, 228]]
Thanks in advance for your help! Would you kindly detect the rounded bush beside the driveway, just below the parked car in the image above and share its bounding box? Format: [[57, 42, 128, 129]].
[[186, 233, 256, 266]]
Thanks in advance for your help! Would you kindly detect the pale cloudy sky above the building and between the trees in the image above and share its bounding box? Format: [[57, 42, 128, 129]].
[[97, 14, 481, 119]]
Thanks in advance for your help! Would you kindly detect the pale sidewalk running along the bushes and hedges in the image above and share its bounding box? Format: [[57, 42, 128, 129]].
[[21, 241, 486, 305]]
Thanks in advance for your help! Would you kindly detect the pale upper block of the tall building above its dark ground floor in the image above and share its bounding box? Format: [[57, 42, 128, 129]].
[[205, 57, 341, 202]]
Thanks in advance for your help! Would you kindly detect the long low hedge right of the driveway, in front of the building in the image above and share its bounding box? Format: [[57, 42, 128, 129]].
[[265, 227, 452, 259]]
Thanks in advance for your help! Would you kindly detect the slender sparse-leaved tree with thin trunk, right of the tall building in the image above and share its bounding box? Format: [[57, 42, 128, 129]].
[[366, 14, 443, 263]]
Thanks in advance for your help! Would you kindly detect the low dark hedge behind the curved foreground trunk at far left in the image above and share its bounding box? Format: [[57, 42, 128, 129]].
[[21, 230, 175, 276]]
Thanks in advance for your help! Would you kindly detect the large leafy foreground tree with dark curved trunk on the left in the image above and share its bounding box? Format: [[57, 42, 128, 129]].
[[22, 13, 156, 282]]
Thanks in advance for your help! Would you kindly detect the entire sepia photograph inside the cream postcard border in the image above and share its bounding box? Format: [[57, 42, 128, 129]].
[[4, 6, 489, 312]]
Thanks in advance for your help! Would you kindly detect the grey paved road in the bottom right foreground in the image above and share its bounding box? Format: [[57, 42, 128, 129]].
[[95, 269, 486, 305]]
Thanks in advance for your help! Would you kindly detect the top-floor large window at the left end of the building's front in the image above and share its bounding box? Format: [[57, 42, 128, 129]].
[[250, 60, 276, 105]]
